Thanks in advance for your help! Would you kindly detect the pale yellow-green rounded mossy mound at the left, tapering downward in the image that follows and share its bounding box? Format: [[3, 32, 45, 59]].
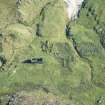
[[2, 24, 34, 59]]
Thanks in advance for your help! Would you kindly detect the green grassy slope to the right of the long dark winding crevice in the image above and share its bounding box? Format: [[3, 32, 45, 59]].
[[71, 0, 105, 105]]
